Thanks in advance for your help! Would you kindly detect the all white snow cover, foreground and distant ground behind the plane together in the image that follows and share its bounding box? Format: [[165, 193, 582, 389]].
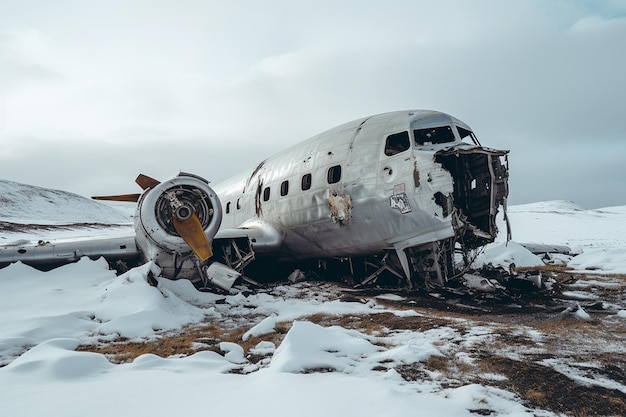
[[0, 182, 626, 417]]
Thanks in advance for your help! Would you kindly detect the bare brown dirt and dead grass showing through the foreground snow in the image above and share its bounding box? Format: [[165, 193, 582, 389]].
[[79, 270, 626, 416]]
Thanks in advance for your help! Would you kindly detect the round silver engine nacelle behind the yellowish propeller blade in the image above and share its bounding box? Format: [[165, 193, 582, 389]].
[[135, 173, 222, 281]]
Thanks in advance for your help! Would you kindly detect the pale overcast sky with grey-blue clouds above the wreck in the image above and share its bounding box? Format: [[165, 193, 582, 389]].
[[0, 0, 626, 208]]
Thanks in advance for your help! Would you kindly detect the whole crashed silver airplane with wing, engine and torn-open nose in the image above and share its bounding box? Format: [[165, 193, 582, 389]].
[[0, 110, 508, 290]]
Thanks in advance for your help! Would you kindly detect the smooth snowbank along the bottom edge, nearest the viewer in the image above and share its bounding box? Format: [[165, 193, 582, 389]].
[[2, 339, 549, 416]]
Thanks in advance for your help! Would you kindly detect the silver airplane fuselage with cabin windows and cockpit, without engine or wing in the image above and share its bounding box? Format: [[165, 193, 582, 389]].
[[213, 110, 506, 282]]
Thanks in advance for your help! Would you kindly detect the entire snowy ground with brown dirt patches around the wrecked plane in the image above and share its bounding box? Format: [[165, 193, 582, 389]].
[[0, 182, 626, 416]]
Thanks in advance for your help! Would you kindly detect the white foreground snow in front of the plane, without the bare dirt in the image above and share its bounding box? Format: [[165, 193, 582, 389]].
[[0, 259, 551, 416]]
